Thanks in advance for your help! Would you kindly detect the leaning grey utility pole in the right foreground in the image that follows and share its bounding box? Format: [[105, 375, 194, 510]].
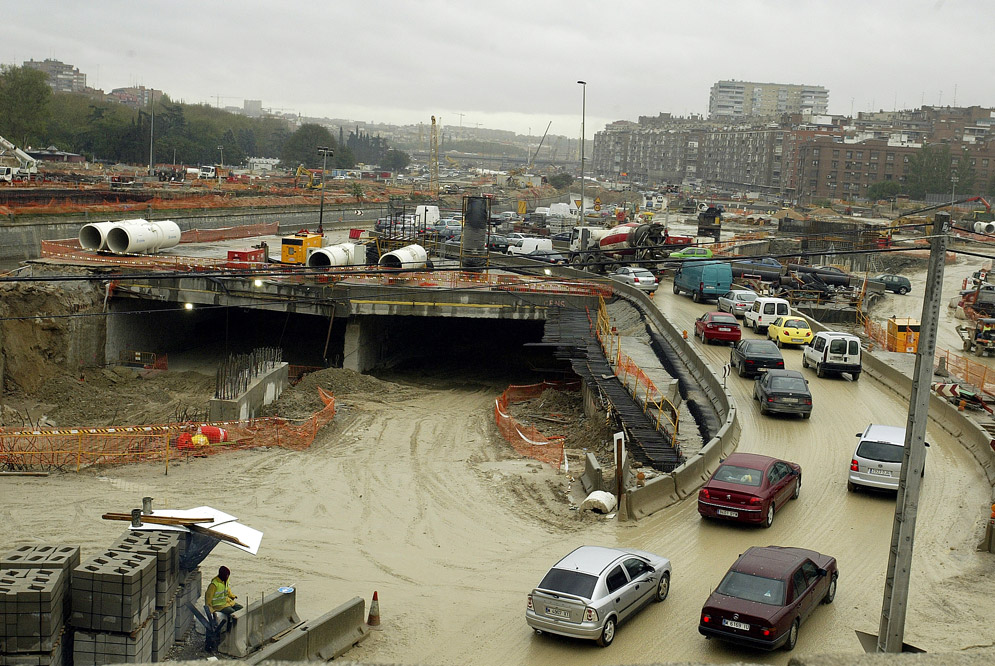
[[877, 213, 950, 652]]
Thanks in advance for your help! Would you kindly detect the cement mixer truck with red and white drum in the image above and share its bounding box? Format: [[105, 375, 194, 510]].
[[570, 222, 694, 273]]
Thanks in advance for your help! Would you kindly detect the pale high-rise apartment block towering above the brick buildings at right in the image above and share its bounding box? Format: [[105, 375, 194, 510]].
[[708, 81, 829, 120]]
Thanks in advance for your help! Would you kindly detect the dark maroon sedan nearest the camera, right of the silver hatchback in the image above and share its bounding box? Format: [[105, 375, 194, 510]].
[[698, 546, 839, 650]]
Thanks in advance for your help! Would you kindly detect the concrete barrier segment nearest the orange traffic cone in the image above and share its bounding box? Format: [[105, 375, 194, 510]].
[[244, 597, 369, 666]]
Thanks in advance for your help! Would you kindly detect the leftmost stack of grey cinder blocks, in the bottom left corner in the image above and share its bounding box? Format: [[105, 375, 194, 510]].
[[0, 546, 79, 666]]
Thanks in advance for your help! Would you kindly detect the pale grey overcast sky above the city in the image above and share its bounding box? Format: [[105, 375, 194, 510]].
[[0, 0, 995, 138]]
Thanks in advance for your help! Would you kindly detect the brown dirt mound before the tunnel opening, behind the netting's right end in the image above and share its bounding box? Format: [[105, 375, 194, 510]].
[[261, 368, 404, 419]]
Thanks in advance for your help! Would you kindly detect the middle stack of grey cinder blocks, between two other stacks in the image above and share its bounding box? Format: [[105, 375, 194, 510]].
[[72, 550, 157, 666]]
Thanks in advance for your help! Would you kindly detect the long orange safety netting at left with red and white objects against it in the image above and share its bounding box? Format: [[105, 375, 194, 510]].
[[0, 387, 335, 471]]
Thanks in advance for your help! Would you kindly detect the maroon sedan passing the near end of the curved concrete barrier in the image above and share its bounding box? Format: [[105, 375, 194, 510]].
[[698, 453, 802, 527]]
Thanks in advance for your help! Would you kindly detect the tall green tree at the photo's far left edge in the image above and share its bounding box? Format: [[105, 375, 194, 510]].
[[0, 65, 52, 149]]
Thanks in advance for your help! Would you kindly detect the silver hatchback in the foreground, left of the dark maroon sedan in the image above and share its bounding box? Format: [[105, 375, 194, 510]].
[[525, 546, 671, 647]]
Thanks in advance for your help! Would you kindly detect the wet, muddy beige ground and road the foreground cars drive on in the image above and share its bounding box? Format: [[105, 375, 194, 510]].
[[0, 285, 995, 666]]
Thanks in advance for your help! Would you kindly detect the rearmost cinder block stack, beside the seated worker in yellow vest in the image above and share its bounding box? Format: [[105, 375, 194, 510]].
[[110, 530, 180, 661]]
